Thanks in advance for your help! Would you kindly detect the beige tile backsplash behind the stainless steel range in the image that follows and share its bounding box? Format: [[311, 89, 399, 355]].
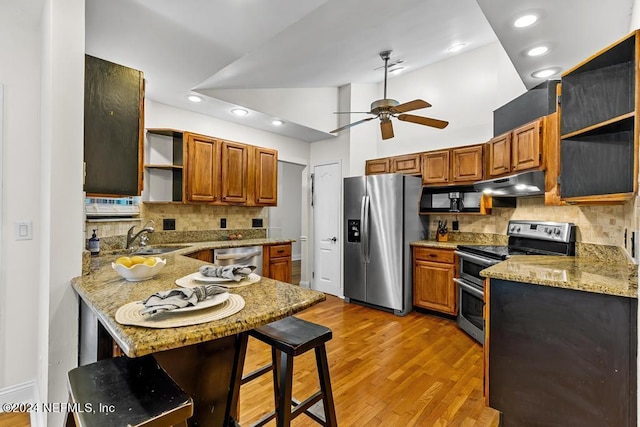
[[429, 197, 640, 247]]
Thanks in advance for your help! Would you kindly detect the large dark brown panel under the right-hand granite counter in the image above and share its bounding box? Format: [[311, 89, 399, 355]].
[[484, 278, 638, 427]]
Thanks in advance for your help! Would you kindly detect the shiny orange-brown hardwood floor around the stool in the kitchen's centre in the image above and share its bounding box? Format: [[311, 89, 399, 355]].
[[240, 296, 499, 427]]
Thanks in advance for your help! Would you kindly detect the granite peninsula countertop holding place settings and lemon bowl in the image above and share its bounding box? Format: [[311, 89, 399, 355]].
[[72, 247, 325, 357]]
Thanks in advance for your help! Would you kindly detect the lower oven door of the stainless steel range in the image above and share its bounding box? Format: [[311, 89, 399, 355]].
[[453, 279, 484, 344]]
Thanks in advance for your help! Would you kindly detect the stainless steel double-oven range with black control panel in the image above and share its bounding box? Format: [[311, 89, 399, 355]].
[[454, 221, 576, 344]]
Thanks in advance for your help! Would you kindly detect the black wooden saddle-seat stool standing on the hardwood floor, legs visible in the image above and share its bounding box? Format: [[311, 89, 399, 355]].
[[241, 316, 338, 427]]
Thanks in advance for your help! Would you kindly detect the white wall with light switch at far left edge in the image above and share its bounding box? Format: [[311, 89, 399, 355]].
[[0, 2, 41, 390]]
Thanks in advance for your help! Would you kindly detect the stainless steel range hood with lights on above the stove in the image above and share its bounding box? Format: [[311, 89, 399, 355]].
[[473, 170, 544, 197]]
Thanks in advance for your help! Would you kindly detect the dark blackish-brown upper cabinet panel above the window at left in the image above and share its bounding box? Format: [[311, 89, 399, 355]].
[[84, 55, 144, 196]]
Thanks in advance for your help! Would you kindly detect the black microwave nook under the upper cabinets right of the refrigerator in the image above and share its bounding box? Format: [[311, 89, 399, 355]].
[[419, 186, 482, 214]]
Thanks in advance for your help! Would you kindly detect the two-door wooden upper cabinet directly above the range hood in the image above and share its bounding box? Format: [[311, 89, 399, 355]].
[[487, 118, 544, 178]]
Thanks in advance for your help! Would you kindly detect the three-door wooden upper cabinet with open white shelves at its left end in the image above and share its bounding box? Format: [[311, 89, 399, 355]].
[[144, 129, 278, 206]]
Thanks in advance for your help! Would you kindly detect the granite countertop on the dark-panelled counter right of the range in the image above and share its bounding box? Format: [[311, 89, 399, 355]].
[[480, 255, 638, 298]]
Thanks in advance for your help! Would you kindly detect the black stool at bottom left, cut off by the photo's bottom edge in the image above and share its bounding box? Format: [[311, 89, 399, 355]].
[[66, 356, 193, 427]]
